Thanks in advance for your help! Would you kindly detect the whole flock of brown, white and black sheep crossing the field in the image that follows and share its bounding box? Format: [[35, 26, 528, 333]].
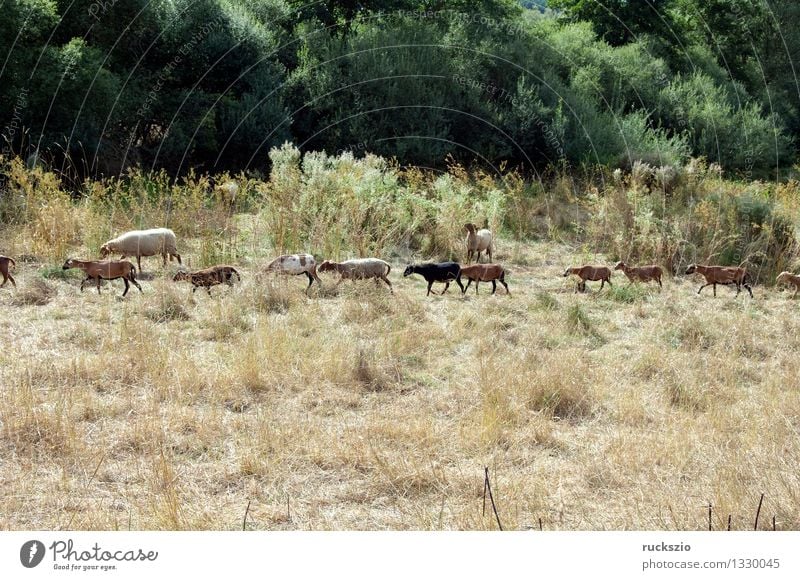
[[0, 224, 800, 298]]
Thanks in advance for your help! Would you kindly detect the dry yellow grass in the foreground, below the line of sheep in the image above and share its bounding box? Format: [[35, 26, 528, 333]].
[[0, 241, 800, 530]]
